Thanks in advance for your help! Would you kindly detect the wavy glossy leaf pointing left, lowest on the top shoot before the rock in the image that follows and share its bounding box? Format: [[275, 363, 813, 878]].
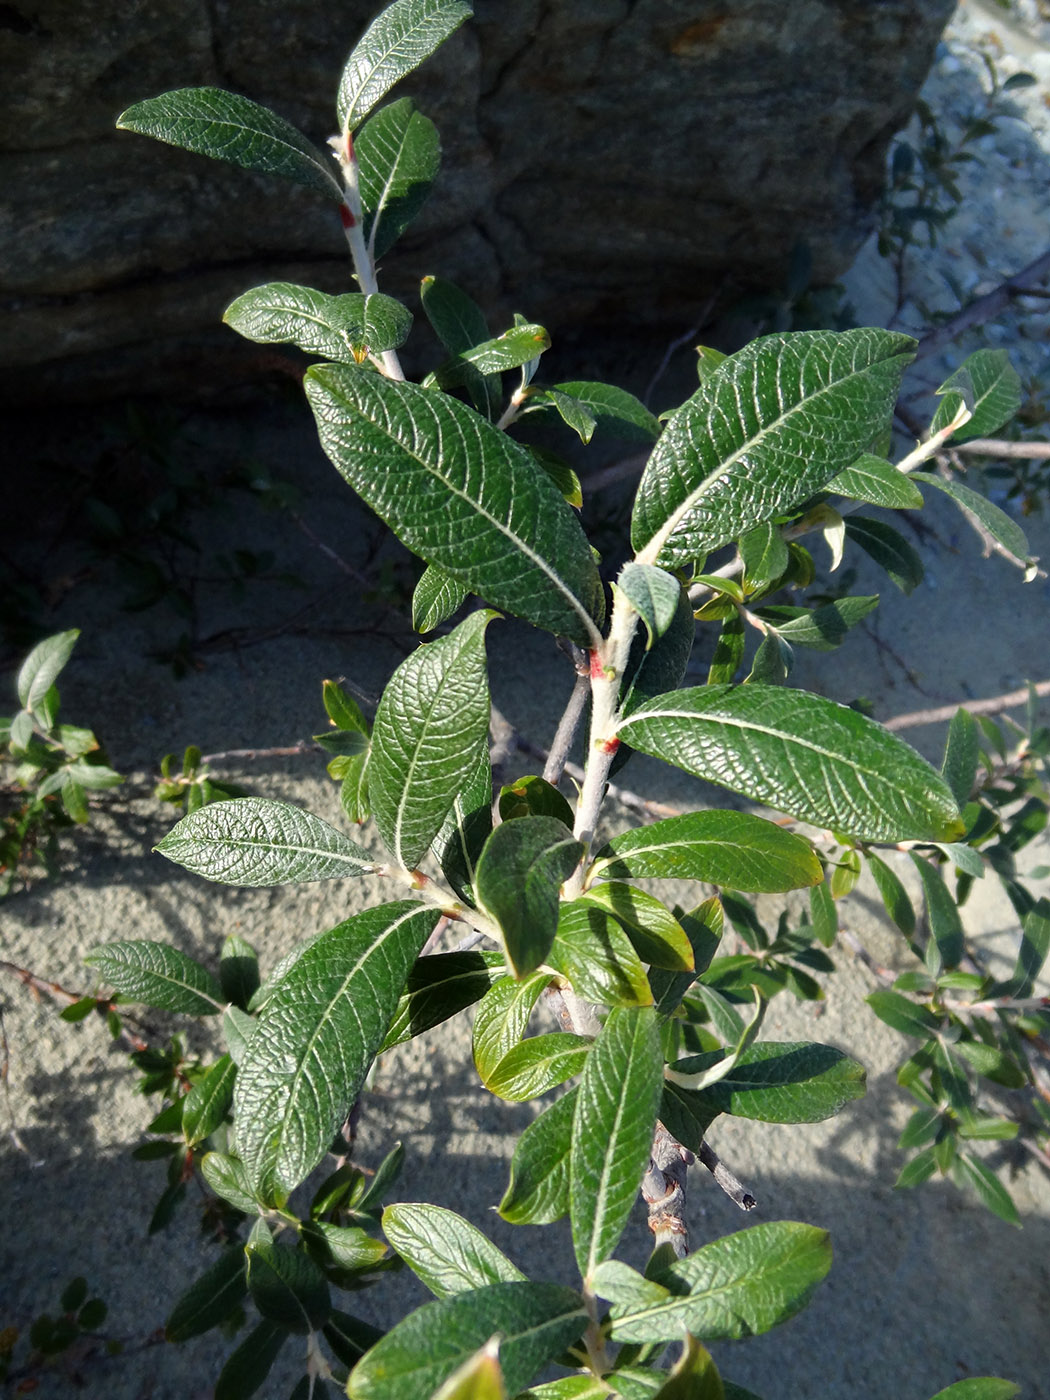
[[223, 281, 412, 364]]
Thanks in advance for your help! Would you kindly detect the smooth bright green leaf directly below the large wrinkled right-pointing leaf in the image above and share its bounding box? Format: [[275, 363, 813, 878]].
[[589, 812, 823, 893]]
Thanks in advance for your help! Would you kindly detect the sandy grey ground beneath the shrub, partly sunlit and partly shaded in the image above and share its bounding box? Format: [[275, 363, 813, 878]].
[[0, 2, 1050, 1400]]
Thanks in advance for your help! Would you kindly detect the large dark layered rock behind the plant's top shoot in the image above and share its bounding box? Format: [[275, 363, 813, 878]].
[[0, 0, 952, 399]]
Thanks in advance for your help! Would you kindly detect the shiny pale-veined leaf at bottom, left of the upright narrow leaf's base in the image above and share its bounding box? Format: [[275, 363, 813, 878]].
[[382, 1201, 525, 1298]]
